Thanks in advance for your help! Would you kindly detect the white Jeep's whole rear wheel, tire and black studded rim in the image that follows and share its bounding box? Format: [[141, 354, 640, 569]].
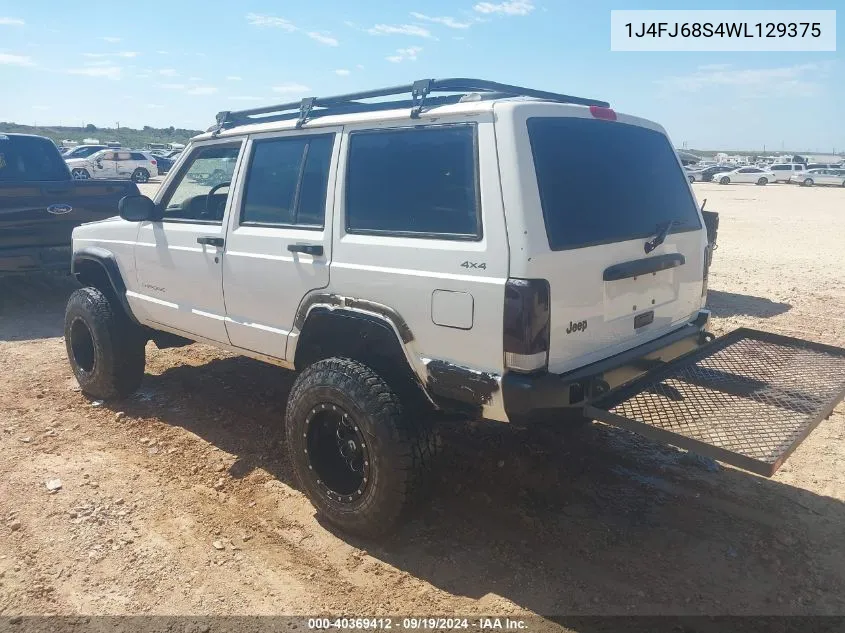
[[285, 358, 437, 537]]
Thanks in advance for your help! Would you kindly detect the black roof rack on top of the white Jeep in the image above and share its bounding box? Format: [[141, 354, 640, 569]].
[[208, 78, 610, 132]]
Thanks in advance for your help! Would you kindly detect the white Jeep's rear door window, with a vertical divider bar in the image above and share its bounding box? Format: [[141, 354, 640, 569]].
[[241, 134, 334, 228]]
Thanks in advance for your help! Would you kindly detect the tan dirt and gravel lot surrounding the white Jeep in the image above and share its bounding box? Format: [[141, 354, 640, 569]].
[[0, 184, 845, 615]]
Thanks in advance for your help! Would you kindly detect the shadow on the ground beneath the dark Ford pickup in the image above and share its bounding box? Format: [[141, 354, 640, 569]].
[[0, 273, 79, 341]]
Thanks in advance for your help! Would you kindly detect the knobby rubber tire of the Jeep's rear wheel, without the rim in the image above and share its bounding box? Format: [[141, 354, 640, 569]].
[[285, 358, 437, 538]]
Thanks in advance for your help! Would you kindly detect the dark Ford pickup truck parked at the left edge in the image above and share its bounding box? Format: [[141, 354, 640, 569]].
[[0, 134, 138, 276]]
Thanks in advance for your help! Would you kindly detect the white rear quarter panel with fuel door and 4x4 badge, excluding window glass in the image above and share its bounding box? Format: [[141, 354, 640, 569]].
[[324, 111, 508, 400]]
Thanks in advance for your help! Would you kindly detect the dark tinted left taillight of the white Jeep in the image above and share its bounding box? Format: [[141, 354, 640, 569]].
[[504, 279, 551, 373]]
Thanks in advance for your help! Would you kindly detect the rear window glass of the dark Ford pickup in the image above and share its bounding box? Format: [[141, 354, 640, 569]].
[[0, 135, 70, 182]]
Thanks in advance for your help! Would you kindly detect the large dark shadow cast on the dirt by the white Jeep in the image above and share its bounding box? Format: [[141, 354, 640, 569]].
[[121, 352, 845, 616]]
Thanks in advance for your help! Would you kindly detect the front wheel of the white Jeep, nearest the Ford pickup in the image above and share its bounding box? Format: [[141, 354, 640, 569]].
[[65, 288, 146, 399]]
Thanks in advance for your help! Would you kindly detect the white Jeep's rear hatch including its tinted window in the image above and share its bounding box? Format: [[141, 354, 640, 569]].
[[499, 104, 707, 373]]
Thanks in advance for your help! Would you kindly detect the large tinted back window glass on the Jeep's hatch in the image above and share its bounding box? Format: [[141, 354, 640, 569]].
[[528, 117, 701, 251]]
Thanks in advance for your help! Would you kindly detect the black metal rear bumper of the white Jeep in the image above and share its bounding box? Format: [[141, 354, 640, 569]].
[[502, 310, 710, 424]]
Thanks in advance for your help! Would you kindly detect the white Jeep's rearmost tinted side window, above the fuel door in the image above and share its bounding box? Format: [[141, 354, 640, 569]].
[[346, 125, 474, 240]]
